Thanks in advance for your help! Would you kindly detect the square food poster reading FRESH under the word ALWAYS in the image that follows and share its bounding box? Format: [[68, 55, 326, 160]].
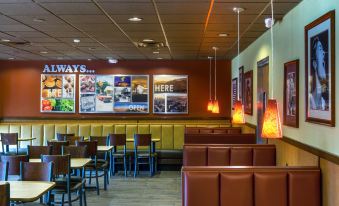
[[40, 74, 76, 113]]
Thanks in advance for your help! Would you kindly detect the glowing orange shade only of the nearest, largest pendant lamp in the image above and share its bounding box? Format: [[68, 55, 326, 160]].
[[261, 99, 282, 138]]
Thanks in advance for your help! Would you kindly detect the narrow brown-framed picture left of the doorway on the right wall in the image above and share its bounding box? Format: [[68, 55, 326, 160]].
[[243, 70, 253, 115]]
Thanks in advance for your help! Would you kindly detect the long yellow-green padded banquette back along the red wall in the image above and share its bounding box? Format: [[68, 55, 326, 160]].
[[0, 121, 228, 150]]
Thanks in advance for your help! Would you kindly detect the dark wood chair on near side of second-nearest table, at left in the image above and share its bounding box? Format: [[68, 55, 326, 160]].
[[41, 155, 86, 206]]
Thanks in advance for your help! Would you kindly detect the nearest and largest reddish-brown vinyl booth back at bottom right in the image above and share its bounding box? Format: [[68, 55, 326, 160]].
[[182, 167, 321, 206]]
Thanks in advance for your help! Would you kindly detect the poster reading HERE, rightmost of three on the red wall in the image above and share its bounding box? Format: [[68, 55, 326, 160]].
[[153, 75, 188, 114]]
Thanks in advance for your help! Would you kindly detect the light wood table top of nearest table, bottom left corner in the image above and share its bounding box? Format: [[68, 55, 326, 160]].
[[0, 181, 55, 202]]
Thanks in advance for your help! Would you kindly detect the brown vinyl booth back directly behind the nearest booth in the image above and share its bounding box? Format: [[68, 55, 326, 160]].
[[183, 144, 276, 166]]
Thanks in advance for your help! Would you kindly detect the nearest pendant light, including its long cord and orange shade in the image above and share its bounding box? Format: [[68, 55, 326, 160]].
[[261, 0, 282, 139]]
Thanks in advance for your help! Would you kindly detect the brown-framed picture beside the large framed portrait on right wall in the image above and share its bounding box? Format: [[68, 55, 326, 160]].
[[283, 60, 299, 128]]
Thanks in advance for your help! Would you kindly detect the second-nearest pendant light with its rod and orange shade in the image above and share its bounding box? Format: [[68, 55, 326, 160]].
[[232, 7, 245, 124]]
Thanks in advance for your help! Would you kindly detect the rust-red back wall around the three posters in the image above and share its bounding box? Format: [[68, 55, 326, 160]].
[[0, 61, 231, 119]]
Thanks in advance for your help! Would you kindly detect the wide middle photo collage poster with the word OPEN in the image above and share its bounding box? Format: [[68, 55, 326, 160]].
[[79, 75, 149, 113]]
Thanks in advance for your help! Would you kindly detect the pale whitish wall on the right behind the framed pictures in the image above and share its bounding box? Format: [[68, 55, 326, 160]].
[[232, 0, 339, 155]]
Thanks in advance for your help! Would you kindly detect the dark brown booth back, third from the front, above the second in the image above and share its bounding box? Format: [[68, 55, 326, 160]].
[[184, 133, 257, 144]]
